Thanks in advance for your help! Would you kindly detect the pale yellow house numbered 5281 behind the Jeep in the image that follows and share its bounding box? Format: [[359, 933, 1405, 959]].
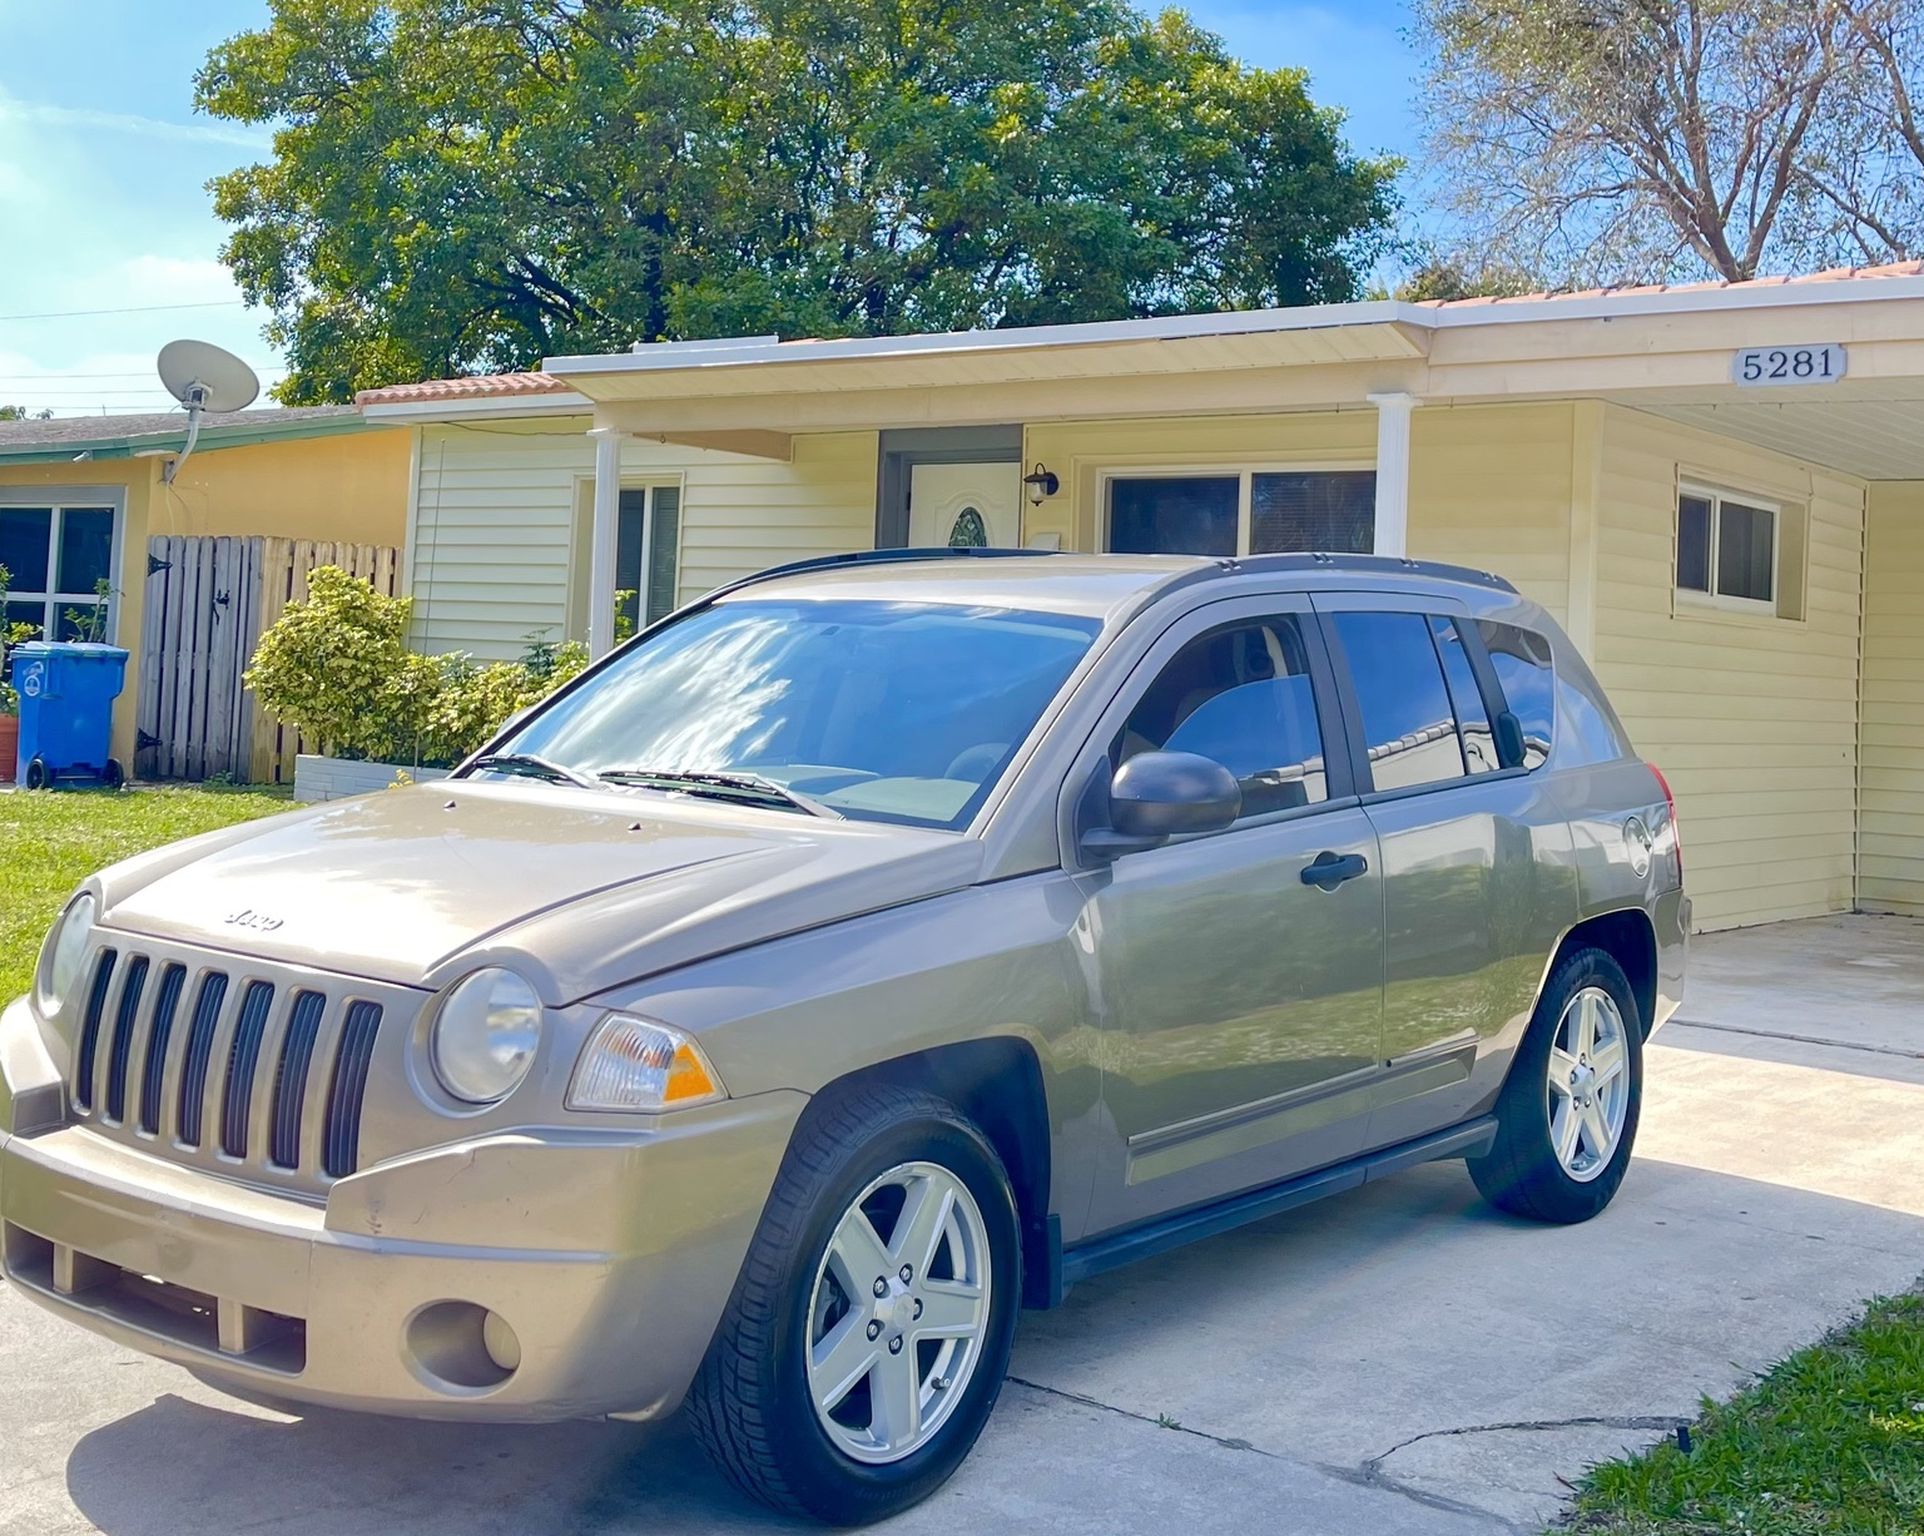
[[350, 262, 1924, 928]]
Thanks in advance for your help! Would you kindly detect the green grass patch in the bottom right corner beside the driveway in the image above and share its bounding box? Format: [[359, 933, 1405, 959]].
[[1570, 1295, 1924, 1536]]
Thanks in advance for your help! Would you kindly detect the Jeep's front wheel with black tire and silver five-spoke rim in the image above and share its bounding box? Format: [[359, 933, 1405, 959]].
[[689, 1084, 1022, 1524]]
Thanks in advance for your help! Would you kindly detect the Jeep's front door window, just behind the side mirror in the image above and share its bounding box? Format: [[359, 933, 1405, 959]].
[[1110, 614, 1329, 816]]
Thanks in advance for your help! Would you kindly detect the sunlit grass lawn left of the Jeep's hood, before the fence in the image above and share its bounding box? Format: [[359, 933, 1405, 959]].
[[0, 785, 292, 1003]]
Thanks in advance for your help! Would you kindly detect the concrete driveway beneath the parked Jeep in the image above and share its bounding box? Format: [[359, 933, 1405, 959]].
[[0, 918, 1924, 1536]]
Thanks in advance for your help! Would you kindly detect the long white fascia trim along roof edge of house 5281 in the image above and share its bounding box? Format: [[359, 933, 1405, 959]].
[[543, 277, 1924, 377]]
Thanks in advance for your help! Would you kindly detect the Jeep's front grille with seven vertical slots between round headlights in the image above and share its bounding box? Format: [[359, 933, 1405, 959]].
[[67, 930, 409, 1199]]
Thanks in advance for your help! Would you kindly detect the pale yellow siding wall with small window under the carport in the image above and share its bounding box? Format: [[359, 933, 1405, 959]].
[[1593, 406, 1864, 928]]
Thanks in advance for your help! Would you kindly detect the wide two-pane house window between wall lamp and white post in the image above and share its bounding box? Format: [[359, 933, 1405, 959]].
[[1104, 468, 1376, 554]]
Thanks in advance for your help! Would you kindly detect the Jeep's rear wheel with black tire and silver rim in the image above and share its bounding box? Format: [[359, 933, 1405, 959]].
[[1470, 949, 1645, 1224]]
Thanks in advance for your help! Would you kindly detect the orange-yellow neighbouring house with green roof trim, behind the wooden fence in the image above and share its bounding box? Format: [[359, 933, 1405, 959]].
[[0, 406, 410, 772]]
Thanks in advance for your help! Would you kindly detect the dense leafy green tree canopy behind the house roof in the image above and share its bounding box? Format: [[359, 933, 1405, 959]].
[[196, 0, 1397, 402]]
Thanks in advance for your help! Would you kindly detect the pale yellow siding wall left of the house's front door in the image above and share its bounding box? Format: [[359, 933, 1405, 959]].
[[408, 418, 877, 660]]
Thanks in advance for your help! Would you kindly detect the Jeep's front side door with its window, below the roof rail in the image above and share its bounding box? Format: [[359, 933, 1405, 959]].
[[1079, 597, 1383, 1232]]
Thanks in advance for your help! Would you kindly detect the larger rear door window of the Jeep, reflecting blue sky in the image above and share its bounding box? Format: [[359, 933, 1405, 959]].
[[1335, 614, 1464, 789]]
